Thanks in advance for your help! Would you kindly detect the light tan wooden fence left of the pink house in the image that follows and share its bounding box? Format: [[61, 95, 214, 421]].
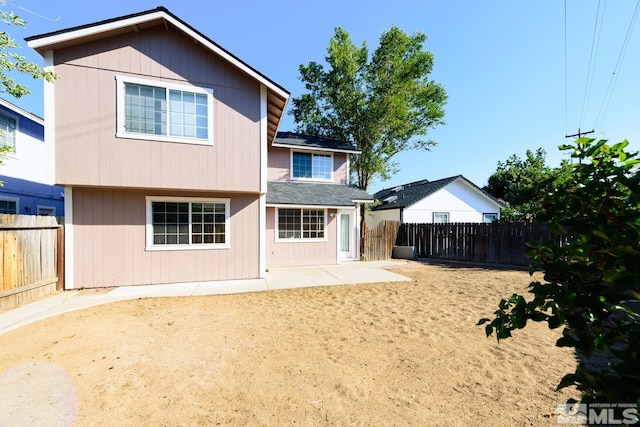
[[0, 215, 64, 312]]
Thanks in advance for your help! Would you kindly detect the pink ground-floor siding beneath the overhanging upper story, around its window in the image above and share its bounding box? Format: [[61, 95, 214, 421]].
[[73, 188, 260, 288]]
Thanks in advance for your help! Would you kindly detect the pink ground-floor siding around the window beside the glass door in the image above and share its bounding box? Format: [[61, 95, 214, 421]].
[[266, 208, 338, 268]]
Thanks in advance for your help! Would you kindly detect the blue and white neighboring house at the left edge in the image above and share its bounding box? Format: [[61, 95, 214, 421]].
[[0, 98, 64, 216]]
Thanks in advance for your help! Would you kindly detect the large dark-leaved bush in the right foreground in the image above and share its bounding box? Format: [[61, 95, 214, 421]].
[[478, 138, 640, 405]]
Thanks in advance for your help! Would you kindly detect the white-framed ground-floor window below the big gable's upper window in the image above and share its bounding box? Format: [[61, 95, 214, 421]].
[[146, 196, 230, 250]]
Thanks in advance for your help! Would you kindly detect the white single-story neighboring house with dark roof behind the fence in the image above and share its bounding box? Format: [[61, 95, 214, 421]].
[[365, 175, 505, 227]]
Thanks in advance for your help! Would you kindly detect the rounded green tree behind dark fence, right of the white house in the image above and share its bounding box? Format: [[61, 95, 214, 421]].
[[484, 148, 571, 222]]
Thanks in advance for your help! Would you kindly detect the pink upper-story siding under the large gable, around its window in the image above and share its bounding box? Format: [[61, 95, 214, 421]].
[[54, 26, 260, 192]]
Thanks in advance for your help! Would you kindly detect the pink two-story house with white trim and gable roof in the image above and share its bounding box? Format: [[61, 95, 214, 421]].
[[26, 7, 372, 288]]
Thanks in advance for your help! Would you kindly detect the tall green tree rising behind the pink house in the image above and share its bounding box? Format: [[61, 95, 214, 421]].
[[291, 26, 447, 191]]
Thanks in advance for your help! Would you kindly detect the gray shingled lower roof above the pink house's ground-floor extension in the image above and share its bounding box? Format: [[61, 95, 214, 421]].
[[267, 181, 373, 207]]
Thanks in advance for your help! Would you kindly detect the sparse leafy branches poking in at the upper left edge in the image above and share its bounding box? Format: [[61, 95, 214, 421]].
[[0, 0, 57, 171]]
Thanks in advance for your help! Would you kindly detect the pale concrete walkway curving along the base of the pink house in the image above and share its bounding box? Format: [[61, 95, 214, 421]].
[[0, 261, 410, 335]]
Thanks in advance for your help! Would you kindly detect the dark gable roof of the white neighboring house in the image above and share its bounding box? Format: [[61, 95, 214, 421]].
[[371, 175, 504, 211]]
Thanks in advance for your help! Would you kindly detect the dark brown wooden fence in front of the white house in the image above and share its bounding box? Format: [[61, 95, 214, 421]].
[[396, 222, 572, 266]]
